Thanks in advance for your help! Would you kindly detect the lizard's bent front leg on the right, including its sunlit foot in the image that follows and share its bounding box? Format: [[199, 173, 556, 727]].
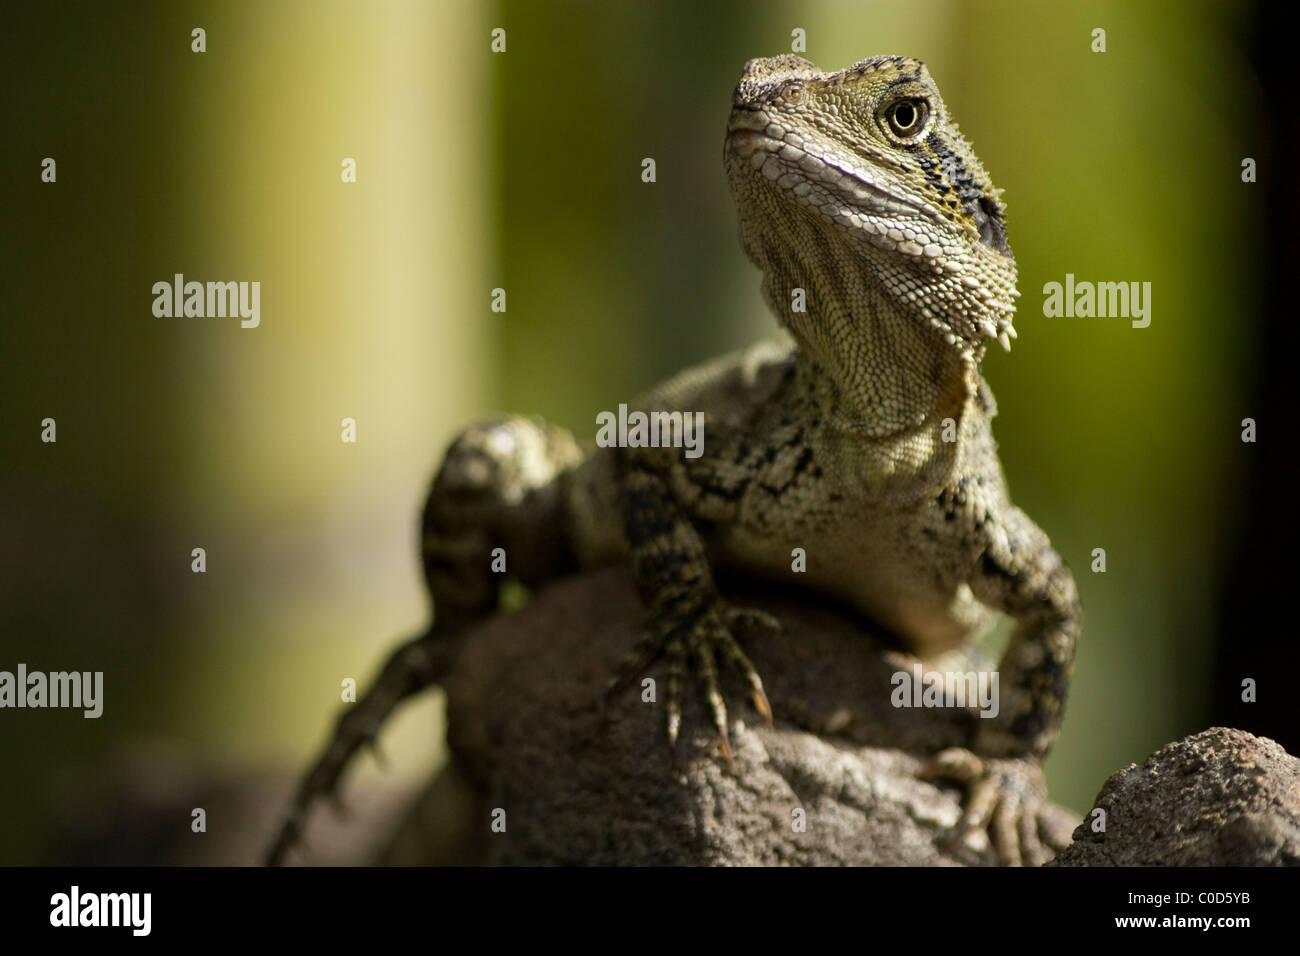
[[927, 507, 1082, 866]]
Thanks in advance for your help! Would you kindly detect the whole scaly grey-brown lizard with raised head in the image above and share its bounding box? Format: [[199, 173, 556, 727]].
[[272, 56, 1080, 864]]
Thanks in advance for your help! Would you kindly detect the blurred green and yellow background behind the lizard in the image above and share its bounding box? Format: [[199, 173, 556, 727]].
[[0, 0, 1279, 864]]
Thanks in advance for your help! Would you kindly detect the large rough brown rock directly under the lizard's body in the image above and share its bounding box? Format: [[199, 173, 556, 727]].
[[381, 570, 1078, 865]]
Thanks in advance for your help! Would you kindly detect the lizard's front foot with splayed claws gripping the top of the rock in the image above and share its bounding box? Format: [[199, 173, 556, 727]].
[[605, 598, 781, 770]]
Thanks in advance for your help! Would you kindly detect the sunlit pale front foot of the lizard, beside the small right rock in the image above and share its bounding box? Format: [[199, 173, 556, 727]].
[[920, 747, 1062, 866]]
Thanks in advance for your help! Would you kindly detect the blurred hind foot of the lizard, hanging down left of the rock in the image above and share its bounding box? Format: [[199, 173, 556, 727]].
[[267, 630, 443, 866]]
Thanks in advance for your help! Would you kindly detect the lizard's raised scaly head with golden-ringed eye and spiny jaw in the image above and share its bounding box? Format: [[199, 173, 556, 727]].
[[724, 56, 1018, 376]]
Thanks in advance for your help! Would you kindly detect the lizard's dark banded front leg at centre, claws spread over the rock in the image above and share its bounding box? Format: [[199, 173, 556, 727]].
[[607, 463, 780, 766]]
